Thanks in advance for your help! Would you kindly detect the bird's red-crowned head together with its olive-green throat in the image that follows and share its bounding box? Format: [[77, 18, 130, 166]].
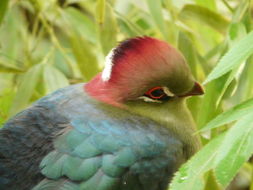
[[85, 37, 203, 157]]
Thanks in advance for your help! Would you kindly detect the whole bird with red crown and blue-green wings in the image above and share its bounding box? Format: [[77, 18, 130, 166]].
[[0, 36, 204, 190]]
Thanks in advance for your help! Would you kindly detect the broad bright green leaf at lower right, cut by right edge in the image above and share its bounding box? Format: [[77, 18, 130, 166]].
[[215, 112, 253, 187]]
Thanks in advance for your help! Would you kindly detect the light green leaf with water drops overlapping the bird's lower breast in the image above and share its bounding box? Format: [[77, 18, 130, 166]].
[[170, 135, 224, 190]]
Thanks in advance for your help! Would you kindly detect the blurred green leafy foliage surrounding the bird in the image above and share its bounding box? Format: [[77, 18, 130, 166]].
[[0, 0, 253, 190]]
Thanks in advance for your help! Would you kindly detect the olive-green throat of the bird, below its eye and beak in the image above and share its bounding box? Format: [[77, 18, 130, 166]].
[[124, 98, 201, 157]]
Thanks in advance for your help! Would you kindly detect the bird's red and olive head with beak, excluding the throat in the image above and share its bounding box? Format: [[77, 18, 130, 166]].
[[85, 37, 203, 106]]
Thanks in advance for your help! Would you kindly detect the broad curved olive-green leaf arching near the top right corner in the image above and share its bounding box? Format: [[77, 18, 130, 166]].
[[179, 5, 229, 34]]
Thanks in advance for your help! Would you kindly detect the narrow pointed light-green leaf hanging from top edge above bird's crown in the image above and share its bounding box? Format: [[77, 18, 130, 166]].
[[146, 0, 167, 39]]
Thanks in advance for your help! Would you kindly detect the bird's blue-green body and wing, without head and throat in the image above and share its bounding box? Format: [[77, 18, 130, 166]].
[[0, 84, 186, 190]]
